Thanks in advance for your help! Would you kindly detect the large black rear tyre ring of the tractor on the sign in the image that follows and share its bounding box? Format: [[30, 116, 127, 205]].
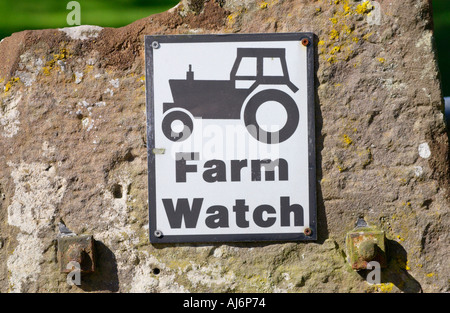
[[244, 89, 300, 144]]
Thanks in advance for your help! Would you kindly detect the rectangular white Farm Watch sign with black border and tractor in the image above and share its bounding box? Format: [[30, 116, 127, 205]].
[[145, 33, 317, 243]]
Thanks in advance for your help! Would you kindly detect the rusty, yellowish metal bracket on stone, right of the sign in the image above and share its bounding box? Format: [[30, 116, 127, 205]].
[[345, 219, 387, 271]]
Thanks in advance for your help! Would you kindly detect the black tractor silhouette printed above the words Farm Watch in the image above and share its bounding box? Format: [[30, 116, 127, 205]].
[[162, 48, 299, 144]]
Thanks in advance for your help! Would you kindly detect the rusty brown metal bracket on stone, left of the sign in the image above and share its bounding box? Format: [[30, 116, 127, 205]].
[[58, 235, 95, 273]]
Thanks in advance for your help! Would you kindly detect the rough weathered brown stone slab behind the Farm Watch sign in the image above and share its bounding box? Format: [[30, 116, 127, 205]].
[[0, 0, 450, 292]]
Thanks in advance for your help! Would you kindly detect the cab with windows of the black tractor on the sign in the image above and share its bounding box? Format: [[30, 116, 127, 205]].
[[230, 48, 298, 92]]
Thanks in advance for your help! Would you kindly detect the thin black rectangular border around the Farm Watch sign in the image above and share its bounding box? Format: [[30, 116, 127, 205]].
[[145, 32, 317, 244]]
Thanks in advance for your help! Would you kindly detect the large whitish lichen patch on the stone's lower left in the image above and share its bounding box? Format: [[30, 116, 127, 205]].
[[7, 163, 67, 292]]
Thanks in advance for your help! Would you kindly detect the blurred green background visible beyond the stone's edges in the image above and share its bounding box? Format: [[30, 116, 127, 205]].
[[0, 0, 450, 96]]
